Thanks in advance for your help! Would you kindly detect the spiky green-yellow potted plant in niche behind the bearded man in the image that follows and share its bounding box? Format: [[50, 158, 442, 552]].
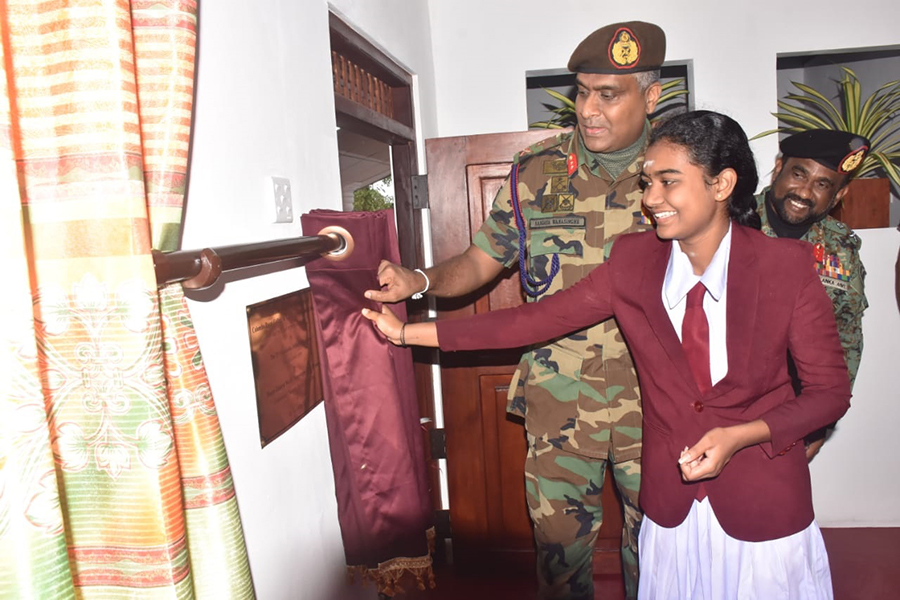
[[751, 66, 900, 227]]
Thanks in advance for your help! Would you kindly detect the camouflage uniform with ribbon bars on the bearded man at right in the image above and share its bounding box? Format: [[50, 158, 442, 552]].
[[756, 188, 869, 387]]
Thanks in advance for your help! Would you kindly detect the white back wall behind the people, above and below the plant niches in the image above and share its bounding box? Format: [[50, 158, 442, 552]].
[[431, 0, 900, 526]]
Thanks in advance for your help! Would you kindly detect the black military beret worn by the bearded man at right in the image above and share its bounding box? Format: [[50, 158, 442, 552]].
[[780, 129, 869, 173]]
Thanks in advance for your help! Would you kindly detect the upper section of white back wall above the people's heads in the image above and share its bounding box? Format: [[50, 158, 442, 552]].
[[430, 0, 900, 183]]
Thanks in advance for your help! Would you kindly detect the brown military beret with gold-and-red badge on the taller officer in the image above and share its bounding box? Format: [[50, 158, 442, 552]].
[[568, 21, 666, 75]]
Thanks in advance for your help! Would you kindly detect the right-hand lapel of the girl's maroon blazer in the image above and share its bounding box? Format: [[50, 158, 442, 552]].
[[709, 224, 761, 397]]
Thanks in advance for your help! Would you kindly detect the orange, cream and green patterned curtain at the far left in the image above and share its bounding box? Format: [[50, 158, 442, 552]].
[[0, 0, 253, 599]]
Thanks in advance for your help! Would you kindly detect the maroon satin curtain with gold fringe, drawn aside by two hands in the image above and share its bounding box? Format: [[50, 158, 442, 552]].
[[301, 210, 434, 594]]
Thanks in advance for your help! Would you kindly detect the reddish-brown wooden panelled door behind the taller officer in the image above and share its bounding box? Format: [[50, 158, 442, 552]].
[[425, 130, 622, 576]]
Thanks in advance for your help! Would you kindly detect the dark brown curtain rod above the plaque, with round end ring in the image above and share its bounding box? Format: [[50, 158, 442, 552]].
[[153, 226, 353, 290]]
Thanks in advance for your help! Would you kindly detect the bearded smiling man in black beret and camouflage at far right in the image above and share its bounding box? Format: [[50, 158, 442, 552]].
[[757, 129, 869, 459]]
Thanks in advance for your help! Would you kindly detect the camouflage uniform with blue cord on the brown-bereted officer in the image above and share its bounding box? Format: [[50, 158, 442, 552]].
[[474, 126, 651, 598]]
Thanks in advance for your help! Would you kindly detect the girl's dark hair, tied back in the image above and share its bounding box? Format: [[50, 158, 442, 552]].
[[650, 110, 761, 229]]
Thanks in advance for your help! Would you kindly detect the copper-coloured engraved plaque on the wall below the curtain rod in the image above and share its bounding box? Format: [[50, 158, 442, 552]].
[[247, 289, 324, 447]]
